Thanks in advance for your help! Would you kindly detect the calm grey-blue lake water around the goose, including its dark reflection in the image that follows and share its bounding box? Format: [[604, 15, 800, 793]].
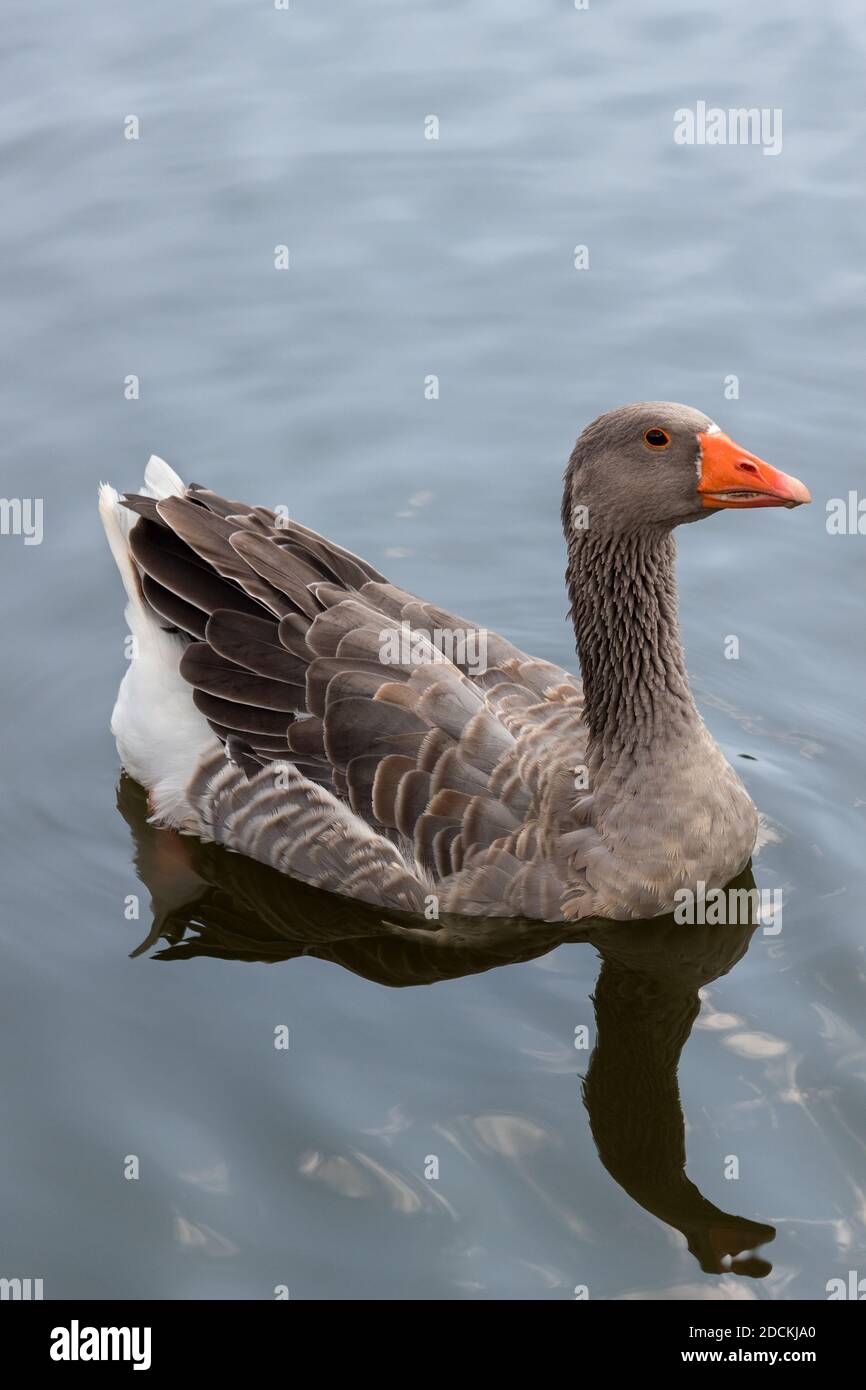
[[0, 0, 866, 1300]]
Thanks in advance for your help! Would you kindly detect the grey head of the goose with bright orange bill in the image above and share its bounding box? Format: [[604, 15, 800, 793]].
[[563, 400, 812, 535]]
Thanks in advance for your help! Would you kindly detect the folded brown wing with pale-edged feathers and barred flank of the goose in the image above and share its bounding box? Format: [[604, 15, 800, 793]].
[[124, 485, 585, 920]]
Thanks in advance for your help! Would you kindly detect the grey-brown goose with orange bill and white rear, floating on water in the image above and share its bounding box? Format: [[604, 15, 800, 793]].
[[99, 402, 810, 924]]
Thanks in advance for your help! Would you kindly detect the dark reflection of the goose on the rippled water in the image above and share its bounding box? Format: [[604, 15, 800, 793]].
[[118, 778, 774, 1277]]
